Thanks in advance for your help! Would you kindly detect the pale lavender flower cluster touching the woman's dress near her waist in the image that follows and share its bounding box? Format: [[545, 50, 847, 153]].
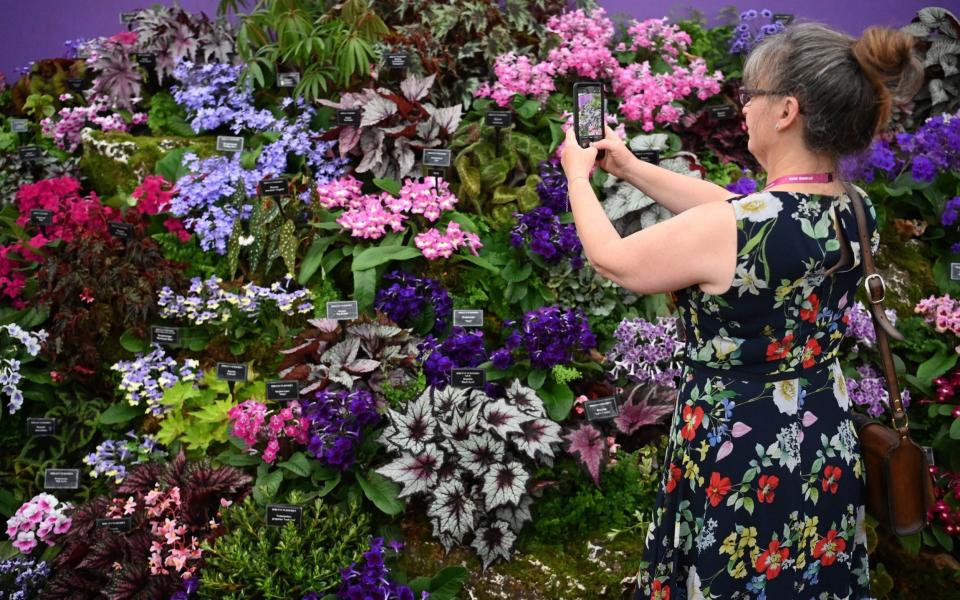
[[606, 317, 683, 387]]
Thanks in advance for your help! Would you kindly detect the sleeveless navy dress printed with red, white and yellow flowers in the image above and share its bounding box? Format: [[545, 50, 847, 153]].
[[634, 191, 880, 600]]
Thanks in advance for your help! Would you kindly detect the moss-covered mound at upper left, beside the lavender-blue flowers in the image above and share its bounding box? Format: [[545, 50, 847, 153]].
[[80, 130, 216, 197]]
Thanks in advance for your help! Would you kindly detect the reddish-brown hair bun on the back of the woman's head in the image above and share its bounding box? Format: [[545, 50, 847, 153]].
[[853, 26, 923, 133]]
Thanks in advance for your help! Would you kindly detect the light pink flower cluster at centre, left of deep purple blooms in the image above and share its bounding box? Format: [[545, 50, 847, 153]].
[[317, 175, 483, 260]]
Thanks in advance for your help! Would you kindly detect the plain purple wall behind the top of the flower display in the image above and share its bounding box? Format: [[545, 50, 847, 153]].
[[0, 0, 940, 80]]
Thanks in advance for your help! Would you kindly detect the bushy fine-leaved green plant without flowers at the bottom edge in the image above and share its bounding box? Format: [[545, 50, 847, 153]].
[[198, 492, 370, 600]]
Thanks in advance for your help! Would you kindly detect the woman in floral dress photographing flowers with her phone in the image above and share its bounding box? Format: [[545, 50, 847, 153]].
[[563, 24, 922, 600]]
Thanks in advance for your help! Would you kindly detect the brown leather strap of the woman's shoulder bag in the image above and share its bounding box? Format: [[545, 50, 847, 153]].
[[843, 182, 909, 438]]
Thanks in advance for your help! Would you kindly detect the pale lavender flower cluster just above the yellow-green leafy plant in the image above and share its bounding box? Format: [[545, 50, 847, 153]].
[[110, 345, 200, 415]]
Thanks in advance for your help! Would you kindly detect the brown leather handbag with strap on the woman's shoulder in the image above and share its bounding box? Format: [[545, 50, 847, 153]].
[[843, 182, 934, 536]]
